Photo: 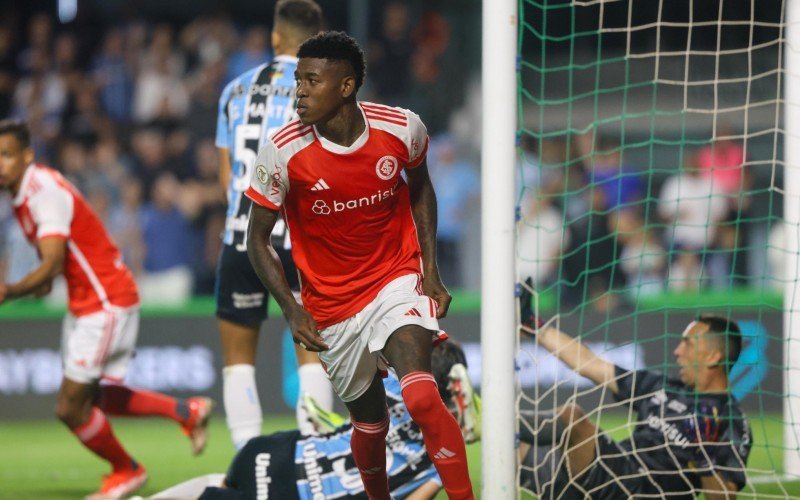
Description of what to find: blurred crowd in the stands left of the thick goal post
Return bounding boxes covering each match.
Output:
[0,2,479,301]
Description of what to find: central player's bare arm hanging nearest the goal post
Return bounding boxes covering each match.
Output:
[406,160,452,318]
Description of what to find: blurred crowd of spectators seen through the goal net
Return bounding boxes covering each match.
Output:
[517,125,782,310]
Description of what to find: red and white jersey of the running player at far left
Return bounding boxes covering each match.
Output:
[14,164,139,316]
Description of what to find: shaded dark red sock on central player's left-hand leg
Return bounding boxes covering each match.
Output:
[350,416,389,500]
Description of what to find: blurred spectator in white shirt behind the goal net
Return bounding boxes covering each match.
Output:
[658,154,727,290]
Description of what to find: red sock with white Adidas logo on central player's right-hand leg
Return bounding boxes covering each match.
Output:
[400,372,474,500]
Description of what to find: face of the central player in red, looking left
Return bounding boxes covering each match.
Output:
[294,57,355,125]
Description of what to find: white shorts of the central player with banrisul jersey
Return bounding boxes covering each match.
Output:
[319,274,447,403]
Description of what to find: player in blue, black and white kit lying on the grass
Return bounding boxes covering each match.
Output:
[145,342,480,500]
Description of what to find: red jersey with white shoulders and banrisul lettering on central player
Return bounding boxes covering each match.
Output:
[246,102,428,329]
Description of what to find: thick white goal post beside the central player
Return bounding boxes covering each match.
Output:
[481,0,517,500]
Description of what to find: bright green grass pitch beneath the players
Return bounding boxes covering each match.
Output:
[0,416,800,500]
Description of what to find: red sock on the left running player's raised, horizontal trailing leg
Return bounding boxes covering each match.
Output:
[99,384,189,423]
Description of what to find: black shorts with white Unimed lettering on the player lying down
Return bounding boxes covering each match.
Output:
[225,431,300,500]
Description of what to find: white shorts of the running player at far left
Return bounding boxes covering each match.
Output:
[61,307,139,384]
